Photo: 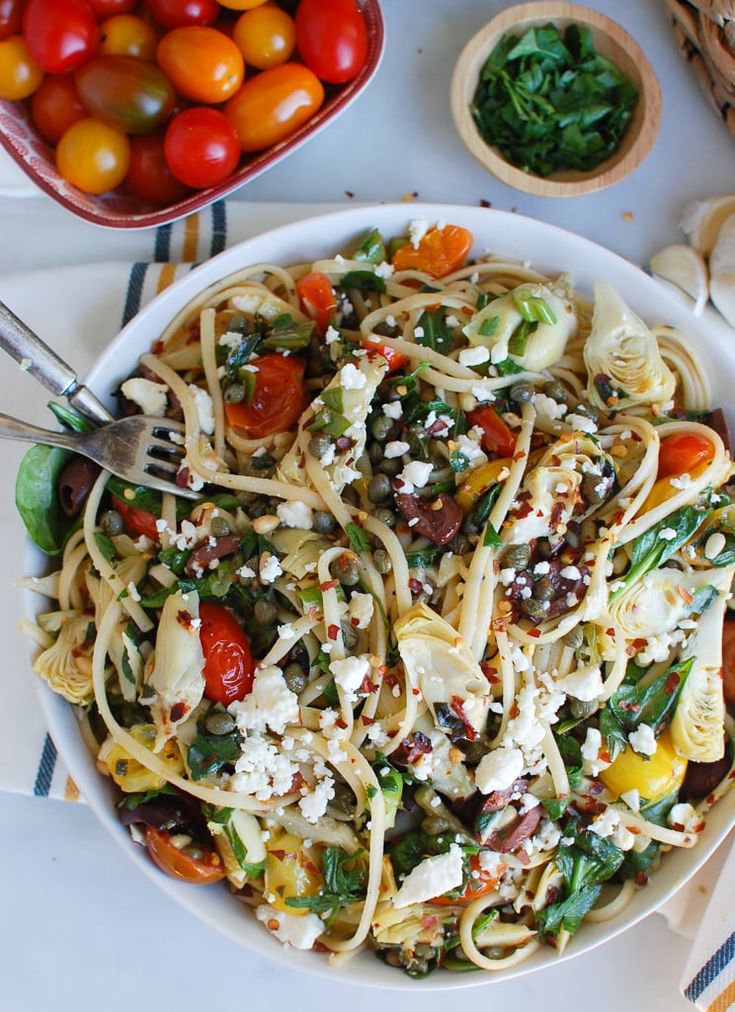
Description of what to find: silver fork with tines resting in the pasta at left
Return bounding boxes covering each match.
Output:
[0,412,199,499]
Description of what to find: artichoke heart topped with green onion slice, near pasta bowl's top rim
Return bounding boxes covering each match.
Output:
[463,284,577,372]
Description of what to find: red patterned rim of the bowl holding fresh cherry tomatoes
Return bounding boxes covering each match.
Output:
[0,0,386,231]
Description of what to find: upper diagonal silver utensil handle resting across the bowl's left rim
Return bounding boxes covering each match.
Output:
[0,302,112,423]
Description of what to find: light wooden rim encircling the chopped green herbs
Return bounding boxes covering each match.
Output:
[451,0,662,197]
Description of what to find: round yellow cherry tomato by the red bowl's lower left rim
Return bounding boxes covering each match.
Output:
[56,118,131,193]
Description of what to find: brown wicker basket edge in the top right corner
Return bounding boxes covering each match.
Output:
[664,0,735,137]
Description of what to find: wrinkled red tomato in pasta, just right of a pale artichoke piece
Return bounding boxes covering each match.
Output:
[199,602,255,706]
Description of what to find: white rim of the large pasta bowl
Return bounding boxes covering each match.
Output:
[23,202,735,993]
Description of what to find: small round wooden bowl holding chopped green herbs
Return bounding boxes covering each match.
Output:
[452,0,661,196]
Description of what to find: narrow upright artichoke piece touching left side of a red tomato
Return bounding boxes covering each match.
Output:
[142,590,205,752]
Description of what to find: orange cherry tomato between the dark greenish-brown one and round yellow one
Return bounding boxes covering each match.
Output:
[156,25,245,103]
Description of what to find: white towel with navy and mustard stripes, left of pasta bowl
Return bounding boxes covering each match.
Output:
[0,198,342,800]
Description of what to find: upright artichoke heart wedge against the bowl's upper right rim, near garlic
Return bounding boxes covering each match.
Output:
[584,282,676,411]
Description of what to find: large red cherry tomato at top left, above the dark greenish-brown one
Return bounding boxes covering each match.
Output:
[23,0,99,74]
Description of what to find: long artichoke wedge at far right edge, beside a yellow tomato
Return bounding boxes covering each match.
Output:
[671,566,735,762]
